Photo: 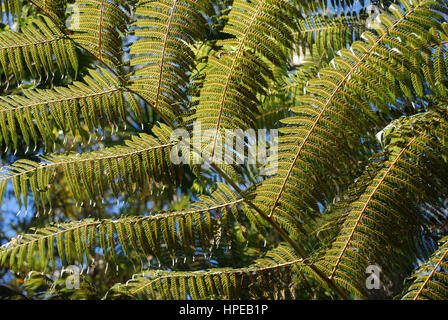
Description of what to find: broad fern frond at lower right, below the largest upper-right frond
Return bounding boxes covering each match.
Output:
[317,113,448,297]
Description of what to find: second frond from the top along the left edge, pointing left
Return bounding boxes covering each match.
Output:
[0,69,141,149]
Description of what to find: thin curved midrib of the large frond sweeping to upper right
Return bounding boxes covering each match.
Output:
[269,6,419,217]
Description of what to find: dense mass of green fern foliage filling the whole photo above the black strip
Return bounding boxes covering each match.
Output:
[0,0,448,299]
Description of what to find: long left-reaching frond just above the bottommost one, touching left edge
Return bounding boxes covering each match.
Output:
[0,185,248,271]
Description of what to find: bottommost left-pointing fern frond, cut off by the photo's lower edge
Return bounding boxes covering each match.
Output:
[106,245,303,300]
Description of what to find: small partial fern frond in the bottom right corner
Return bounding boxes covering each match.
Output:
[402,238,448,300]
